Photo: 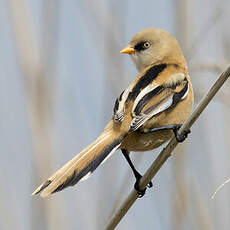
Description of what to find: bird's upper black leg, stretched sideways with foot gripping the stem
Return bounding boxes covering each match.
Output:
[139,124,191,142]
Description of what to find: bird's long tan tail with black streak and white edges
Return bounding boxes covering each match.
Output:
[32,127,124,197]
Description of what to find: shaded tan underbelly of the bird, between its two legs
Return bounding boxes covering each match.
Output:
[120,130,173,151]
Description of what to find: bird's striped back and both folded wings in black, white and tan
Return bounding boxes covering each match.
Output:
[113,64,189,131]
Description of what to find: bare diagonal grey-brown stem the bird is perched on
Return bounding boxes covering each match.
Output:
[106,66,230,230]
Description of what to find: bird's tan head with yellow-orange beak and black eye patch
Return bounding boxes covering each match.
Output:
[120,28,185,71]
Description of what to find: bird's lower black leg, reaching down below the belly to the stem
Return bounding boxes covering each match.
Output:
[121,149,153,198]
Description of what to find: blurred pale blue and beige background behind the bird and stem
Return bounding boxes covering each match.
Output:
[0,0,230,230]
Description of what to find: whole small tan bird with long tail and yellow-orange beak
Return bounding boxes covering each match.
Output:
[32,28,193,197]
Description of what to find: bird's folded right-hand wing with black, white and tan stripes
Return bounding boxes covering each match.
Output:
[130,73,189,131]
